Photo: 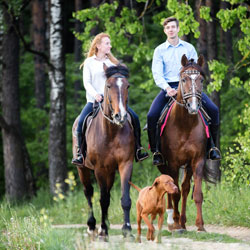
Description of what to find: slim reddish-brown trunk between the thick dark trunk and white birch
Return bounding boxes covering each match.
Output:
[32,0,46,109]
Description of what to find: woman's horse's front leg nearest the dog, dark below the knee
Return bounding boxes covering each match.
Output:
[119,163,133,237]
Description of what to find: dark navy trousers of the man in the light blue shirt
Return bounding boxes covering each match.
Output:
[147,83,219,129]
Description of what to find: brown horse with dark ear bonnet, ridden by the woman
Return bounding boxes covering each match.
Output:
[73,64,135,240]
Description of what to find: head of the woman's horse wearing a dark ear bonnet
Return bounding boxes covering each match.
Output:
[103,64,129,126]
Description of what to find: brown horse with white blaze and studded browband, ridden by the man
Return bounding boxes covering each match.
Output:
[158,55,217,231]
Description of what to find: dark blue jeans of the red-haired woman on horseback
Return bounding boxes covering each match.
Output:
[76,102,140,135]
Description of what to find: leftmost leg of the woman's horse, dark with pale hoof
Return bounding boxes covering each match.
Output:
[77,167,96,237]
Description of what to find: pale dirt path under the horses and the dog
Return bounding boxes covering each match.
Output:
[53,224,250,250]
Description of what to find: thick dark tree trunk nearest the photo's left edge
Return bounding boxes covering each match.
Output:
[0,6,35,200]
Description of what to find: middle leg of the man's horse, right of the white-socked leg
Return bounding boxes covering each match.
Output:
[180,167,193,229]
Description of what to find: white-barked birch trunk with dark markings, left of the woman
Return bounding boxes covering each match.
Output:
[49,0,67,194]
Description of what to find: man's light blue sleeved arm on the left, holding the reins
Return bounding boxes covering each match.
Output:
[152,47,170,90]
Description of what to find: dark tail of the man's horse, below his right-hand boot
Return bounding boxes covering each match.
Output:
[203,159,221,184]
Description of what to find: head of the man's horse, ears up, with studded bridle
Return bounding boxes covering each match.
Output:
[179,54,205,115]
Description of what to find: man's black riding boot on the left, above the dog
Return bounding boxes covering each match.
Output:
[148,129,164,166]
